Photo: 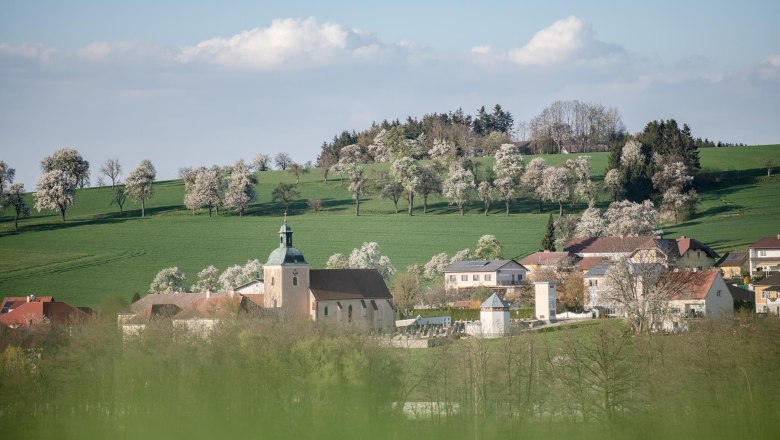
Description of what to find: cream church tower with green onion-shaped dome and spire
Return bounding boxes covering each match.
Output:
[263,220,309,316]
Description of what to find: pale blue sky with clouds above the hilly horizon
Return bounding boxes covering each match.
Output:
[0,0,780,187]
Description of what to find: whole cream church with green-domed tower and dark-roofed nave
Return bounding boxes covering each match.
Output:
[262,220,395,331]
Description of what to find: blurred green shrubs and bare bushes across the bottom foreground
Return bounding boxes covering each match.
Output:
[0,316,780,439]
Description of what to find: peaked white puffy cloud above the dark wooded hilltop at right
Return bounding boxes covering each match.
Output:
[507,15,625,67]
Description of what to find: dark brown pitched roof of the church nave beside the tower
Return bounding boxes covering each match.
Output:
[309,269,393,301]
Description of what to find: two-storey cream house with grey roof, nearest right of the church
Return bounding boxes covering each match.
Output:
[444,260,528,292]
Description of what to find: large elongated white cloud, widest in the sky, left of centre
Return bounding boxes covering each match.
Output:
[177,17,380,70]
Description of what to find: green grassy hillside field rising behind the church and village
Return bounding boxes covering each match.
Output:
[0,145,780,305]
